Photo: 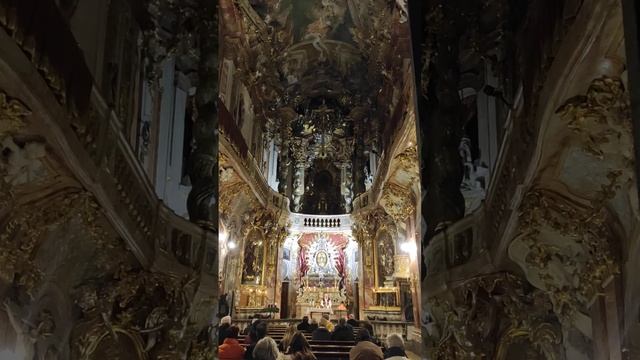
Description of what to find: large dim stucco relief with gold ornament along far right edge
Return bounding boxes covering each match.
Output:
[508,77,637,348]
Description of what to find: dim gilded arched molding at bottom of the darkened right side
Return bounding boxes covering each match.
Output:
[423,273,564,360]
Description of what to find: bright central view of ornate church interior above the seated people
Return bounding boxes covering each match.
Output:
[218,1,421,352]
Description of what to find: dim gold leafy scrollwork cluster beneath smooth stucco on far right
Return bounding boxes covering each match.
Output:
[516,188,619,322]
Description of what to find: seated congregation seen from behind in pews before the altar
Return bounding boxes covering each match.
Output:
[218,315,408,360]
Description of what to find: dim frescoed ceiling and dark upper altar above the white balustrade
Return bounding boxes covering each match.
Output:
[221,0,410,212]
